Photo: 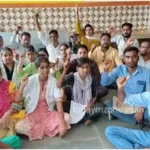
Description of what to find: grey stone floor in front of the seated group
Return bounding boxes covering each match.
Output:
[21,90,143,149]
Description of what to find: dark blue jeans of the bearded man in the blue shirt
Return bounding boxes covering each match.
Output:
[104,100,149,124]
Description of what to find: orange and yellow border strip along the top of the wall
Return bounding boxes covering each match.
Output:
[0,1,150,8]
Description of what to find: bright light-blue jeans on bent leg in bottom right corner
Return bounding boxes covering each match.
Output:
[105,126,150,149]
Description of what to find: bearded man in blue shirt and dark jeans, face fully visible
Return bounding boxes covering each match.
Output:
[101,47,150,124]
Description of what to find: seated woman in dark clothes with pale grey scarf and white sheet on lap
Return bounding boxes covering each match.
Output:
[57,58,103,125]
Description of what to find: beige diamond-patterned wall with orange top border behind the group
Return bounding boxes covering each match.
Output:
[0,2,149,32]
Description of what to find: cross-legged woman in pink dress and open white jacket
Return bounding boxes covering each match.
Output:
[15,56,70,141]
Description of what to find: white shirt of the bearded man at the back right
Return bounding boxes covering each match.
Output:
[111,35,139,58]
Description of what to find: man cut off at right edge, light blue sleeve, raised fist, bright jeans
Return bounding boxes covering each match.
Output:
[105,77,150,149]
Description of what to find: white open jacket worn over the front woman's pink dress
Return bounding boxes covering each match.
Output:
[23,74,62,114]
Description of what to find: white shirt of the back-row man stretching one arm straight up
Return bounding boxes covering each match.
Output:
[38,32,60,63]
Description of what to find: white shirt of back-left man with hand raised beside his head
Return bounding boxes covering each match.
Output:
[10,33,26,54]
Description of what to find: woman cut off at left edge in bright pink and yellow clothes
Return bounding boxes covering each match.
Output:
[0,67,25,139]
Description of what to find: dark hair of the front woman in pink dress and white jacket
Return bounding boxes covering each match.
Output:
[35,54,49,68]
